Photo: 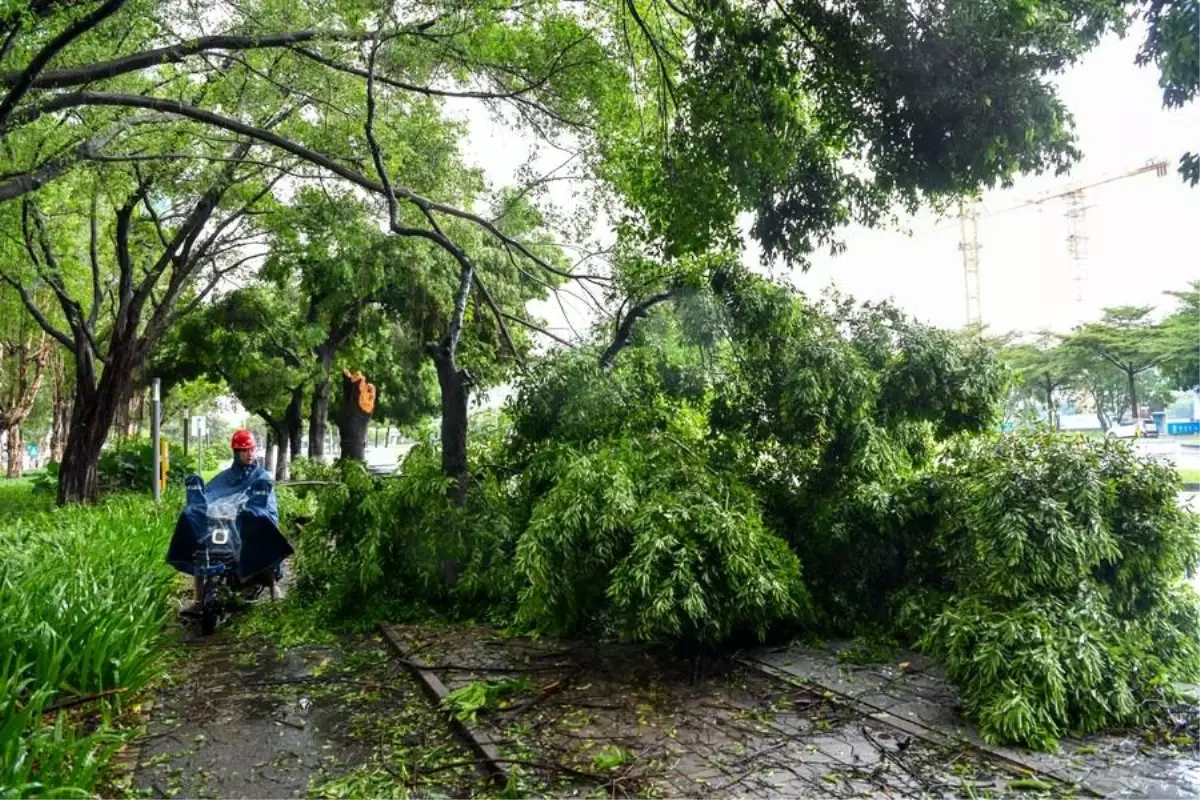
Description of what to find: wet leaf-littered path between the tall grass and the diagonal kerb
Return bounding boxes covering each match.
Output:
[133,632,482,800]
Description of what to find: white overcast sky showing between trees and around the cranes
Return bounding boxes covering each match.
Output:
[453,29,1200,335]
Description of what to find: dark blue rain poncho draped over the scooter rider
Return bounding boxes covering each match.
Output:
[167,462,292,578]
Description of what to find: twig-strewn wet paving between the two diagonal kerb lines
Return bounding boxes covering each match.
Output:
[381,626,1070,799]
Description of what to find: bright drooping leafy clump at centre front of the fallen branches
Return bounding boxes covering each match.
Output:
[517,439,809,644]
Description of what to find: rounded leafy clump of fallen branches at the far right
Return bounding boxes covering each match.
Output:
[920,434,1200,750]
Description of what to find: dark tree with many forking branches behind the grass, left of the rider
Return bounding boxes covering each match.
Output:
[0,154,278,503]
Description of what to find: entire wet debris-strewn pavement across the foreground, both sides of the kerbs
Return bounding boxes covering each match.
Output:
[133,626,1200,800]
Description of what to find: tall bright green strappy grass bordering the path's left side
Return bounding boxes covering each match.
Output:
[0,482,176,800]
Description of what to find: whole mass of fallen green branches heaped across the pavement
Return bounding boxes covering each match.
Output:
[288,269,1200,747]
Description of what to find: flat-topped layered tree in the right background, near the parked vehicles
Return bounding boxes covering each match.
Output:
[1066,306,1165,419]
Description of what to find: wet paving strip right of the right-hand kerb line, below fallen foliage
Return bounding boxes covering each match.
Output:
[743,644,1200,800]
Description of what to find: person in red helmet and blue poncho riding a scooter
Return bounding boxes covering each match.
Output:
[168,429,292,614]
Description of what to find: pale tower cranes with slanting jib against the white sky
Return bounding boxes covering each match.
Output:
[959,160,1170,327]
